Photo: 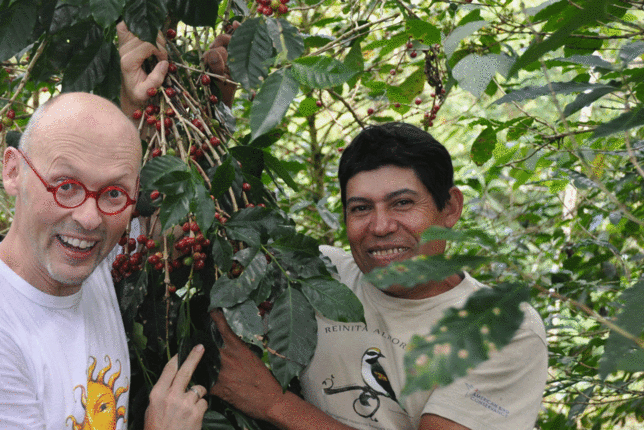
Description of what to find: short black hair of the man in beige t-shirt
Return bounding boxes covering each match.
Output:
[338,122,454,210]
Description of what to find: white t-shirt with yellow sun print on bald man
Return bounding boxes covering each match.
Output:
[0,260,130,430]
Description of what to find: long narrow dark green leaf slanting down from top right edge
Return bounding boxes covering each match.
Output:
[508,0,607,77]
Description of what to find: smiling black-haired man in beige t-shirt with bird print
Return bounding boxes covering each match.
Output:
[212,123,548,430]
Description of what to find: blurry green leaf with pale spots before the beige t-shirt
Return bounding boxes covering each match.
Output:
[403,284,530,395]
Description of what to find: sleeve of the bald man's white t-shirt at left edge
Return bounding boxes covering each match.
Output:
[0,331,45,430]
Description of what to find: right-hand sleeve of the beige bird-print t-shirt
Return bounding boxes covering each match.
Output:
[423,310,548,430]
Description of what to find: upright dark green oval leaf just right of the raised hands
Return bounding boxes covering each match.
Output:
[228,18,273,89]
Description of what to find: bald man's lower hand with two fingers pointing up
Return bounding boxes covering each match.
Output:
[145,345,208,430]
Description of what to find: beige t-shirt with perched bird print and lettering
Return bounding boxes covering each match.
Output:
[300,246,548,430]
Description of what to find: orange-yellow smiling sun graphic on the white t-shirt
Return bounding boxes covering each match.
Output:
[67,356,129,430]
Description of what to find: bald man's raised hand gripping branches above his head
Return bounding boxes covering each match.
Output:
[116,21,168,117]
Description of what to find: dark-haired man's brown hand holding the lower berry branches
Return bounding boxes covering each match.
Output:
[210,310,284,420]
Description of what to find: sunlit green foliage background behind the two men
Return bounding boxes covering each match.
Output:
[0,0,644,429]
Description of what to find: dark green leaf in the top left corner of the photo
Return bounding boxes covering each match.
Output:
[0,1,38,62]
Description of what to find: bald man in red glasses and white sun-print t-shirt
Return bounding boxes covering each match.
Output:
[0,93,207,430]
